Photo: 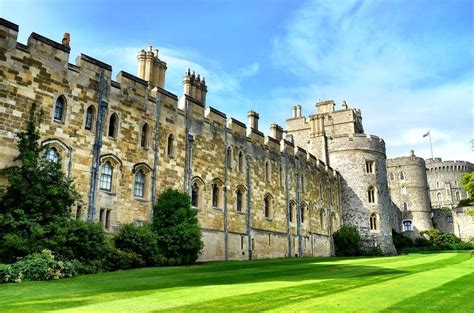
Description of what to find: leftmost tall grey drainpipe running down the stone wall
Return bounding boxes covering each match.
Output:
[87,71,108,222]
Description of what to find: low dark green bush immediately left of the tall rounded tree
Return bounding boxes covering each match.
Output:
[114,224,161,266]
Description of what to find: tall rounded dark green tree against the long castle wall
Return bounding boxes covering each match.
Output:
[153,189,203,264]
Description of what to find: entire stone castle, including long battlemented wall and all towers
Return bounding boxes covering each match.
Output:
[0,19,473,261]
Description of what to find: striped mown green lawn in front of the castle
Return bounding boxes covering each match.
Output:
[0,252,474,312]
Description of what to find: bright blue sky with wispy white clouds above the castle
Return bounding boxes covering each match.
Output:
[0,0,474,161]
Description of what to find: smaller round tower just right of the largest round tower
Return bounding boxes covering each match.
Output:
[387,150,433,238]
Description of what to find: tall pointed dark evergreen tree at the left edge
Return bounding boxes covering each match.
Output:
[0,104,79,262]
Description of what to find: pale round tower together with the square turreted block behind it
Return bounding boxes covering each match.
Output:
[286,100,396,254]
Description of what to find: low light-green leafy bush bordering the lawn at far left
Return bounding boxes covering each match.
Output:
[0,250,77,283]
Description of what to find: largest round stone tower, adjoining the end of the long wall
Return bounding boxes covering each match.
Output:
[328,134,396,254]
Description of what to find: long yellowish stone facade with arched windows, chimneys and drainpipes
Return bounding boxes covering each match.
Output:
[0,19,342,261]
